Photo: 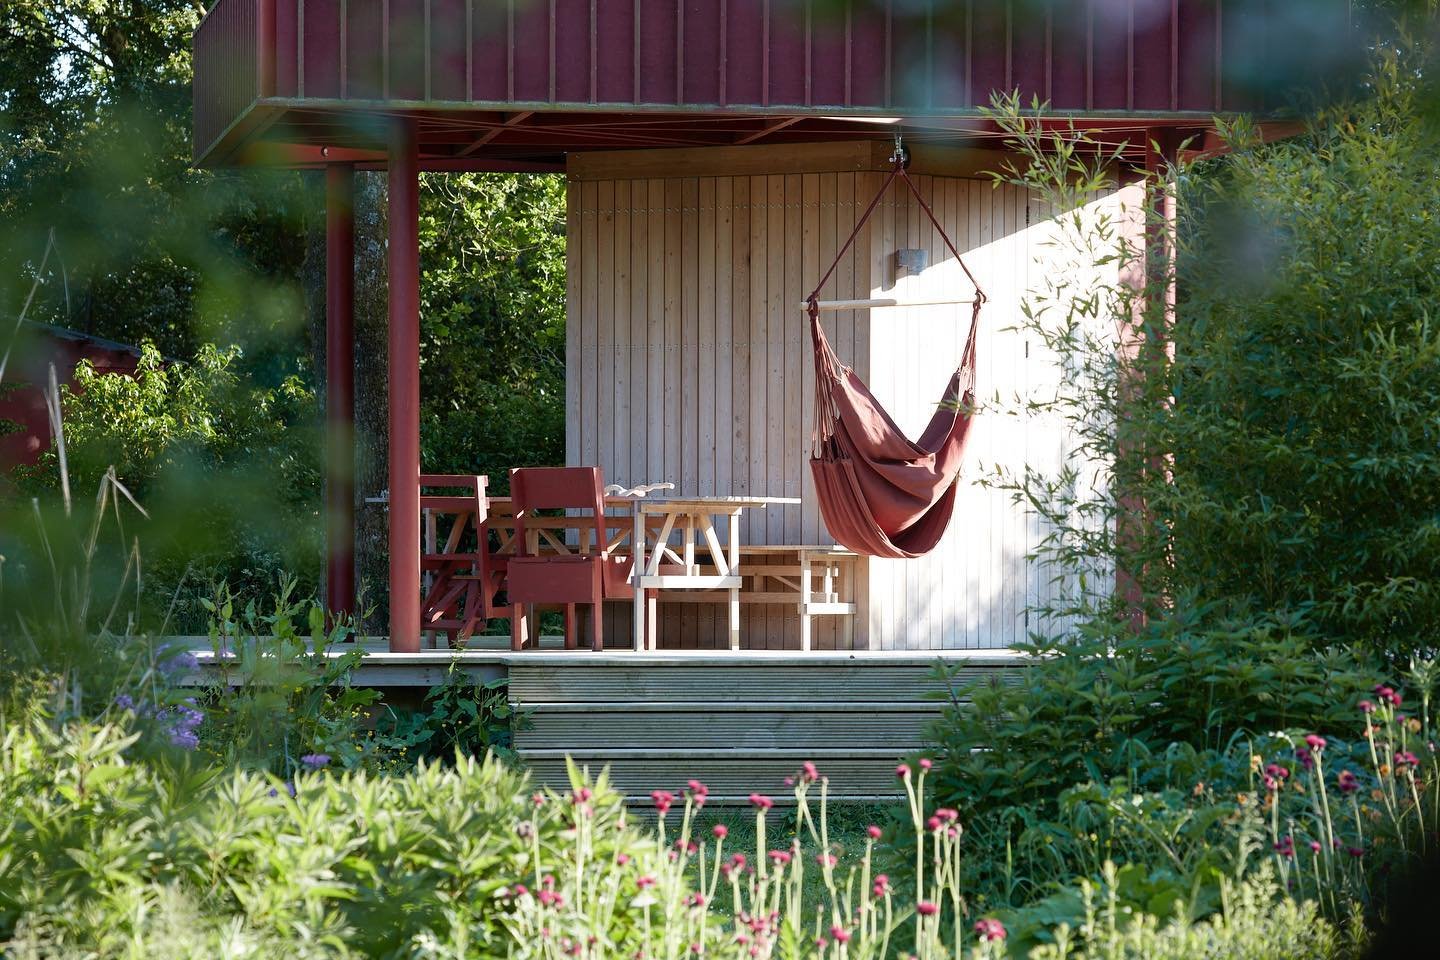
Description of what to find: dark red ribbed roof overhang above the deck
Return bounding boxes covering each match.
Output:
[194,0,1348,170]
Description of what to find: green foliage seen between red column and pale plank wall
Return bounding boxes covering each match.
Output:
[420,174,564,483]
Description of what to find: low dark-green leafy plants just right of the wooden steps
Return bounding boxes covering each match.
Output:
[932,604,1374,816]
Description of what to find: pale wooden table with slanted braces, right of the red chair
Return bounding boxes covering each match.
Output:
[631,497,801,651]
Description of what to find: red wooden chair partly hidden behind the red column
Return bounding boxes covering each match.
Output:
[420,474,510,646]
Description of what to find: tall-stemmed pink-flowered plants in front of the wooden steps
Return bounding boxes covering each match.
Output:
[503,760,1005,960]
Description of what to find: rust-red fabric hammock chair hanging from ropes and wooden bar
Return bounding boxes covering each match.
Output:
[805,147,985,560]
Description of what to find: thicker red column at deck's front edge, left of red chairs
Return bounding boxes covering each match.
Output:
[387,119,420,653]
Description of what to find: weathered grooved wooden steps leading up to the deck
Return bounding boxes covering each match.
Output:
[507,651,1021,803]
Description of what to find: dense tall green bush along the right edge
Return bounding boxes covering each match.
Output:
[1163,52,1440,653]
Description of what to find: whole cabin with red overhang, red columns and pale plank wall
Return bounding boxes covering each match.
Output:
[194,0,1348,651]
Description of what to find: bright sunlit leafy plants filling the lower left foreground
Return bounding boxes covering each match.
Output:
[0,721,647,957]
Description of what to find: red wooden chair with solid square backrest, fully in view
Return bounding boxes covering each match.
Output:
[505,466,635,651]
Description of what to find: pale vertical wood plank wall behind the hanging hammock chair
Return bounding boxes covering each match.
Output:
[566,150,1117,651]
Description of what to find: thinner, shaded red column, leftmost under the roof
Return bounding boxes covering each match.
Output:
[325,164,356,615]
